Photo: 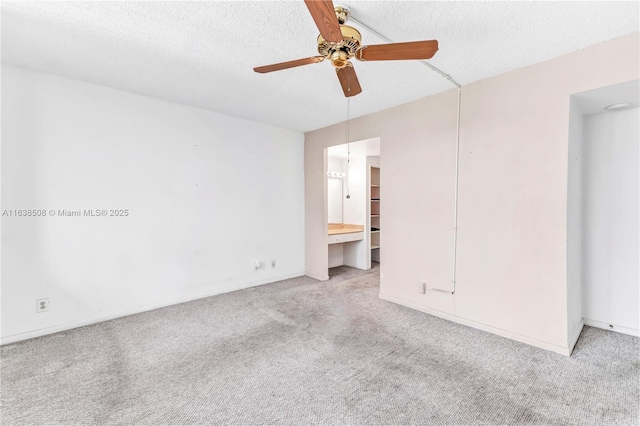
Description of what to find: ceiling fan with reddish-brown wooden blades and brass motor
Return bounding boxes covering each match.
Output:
[253,0,438,97]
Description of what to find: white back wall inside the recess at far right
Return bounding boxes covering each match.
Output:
[582,108,640,335]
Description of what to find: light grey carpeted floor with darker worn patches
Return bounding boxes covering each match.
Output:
[0,267,640,425]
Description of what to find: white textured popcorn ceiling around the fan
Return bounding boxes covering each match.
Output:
[2,0,639,131]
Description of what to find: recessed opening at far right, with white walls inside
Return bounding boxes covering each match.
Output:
[567,80,640,340]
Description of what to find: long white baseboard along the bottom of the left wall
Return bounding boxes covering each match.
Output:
[0,272,304,345]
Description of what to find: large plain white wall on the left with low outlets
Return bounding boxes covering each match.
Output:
[1,65,304,343]
